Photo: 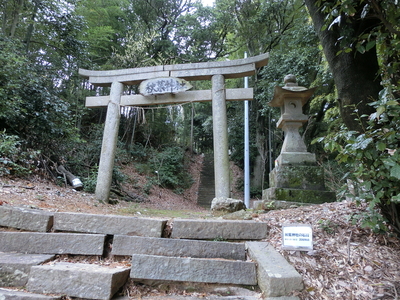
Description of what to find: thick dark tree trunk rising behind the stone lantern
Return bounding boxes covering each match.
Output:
[305,0,382,132]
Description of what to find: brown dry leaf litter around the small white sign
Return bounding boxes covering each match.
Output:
[259,201,400,300]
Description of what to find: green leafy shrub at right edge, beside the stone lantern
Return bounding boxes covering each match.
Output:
[318,88,400,230]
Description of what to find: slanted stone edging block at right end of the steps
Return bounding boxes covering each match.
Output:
[246,242,304,299]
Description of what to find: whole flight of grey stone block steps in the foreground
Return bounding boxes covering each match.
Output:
[0,206,303,300]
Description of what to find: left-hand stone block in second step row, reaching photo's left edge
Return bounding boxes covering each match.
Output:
[0,232,106,255]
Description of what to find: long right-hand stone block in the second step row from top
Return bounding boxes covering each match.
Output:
[112,235,246,260]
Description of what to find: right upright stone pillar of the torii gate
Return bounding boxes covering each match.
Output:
[211,75,230,198]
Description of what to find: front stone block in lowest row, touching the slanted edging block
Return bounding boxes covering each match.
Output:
[130,254,257,285]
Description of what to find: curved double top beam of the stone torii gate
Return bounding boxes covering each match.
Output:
[79,53,269,86]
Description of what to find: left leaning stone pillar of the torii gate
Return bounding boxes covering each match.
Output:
[95,81,124,202]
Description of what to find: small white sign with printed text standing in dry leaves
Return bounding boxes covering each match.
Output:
[282,224,313,251]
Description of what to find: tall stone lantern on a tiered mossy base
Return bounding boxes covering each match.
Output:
[262,75,336,204]
